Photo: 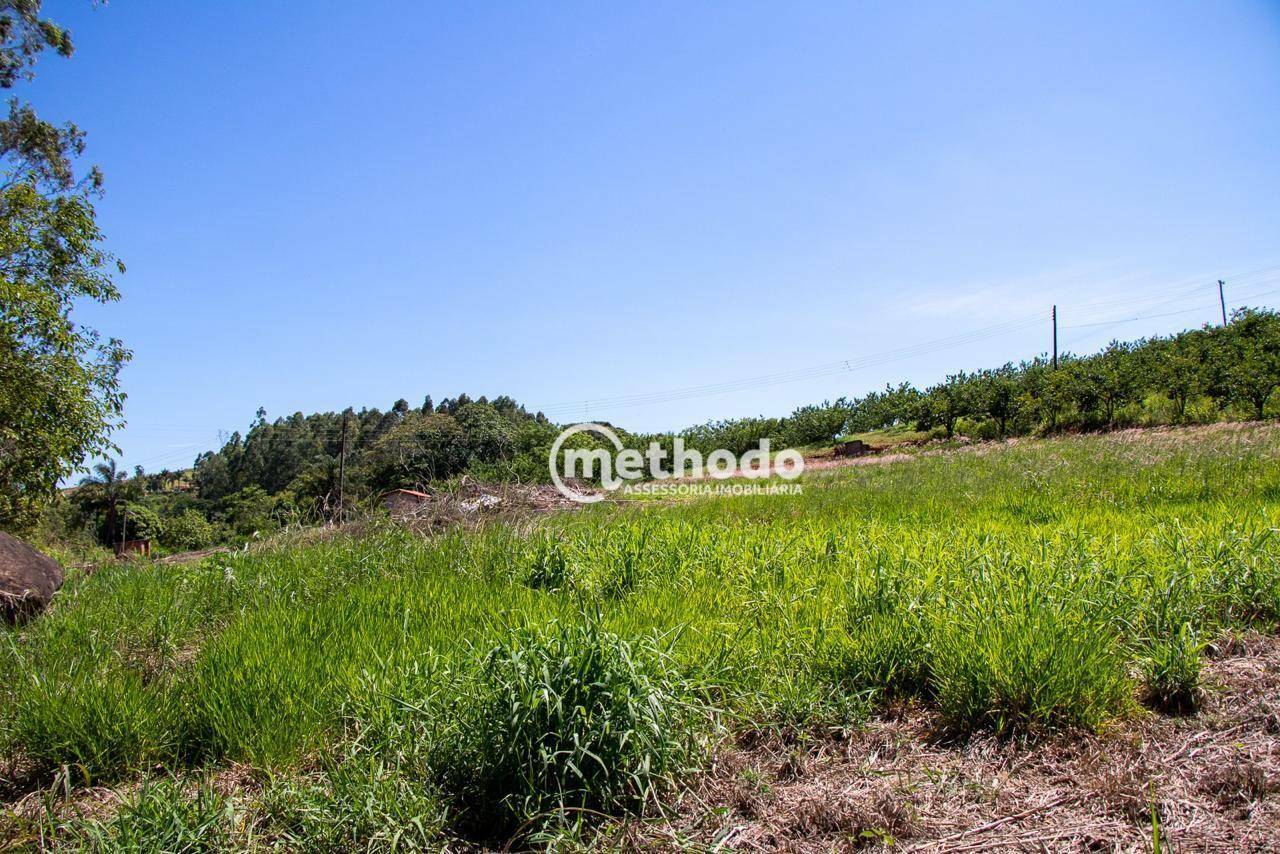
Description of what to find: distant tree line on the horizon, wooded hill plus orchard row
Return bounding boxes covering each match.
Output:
[42,309,1280,549]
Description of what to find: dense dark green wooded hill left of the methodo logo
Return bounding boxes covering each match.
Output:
[45,394,558,551]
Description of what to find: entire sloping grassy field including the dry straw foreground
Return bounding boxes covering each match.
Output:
[0,425,1280,850]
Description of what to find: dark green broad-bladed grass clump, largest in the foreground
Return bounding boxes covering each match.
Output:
[445,620,707,832]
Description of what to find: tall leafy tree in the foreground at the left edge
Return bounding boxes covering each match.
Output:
[0,0,129,530]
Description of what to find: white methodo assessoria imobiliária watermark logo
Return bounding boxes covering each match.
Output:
[548,424,804,504]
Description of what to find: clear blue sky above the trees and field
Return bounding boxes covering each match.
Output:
[27,0,1280,470]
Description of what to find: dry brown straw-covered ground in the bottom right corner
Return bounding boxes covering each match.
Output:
[608,635,1280,851]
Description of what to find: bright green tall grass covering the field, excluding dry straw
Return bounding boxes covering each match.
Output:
[0,425,1280,839]
